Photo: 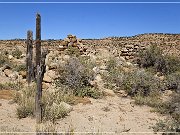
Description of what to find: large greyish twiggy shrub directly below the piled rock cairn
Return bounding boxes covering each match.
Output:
[55,57,98,97]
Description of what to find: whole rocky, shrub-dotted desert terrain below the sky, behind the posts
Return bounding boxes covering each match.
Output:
[0,34,180,134]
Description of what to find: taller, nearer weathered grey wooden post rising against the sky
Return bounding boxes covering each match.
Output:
[35,14,43,123]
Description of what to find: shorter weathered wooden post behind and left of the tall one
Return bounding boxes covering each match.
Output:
[26,30,33,84]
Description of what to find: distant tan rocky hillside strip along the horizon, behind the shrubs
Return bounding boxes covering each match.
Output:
[0,33,180,60]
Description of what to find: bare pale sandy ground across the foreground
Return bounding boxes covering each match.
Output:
[0,93,164,135]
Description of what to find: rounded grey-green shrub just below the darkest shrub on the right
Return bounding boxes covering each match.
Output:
[122,70,164,97]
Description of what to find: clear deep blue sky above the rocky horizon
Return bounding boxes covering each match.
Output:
[0,0,180,39]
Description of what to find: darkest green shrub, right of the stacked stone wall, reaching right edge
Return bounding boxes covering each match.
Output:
[138,45,180,74]
